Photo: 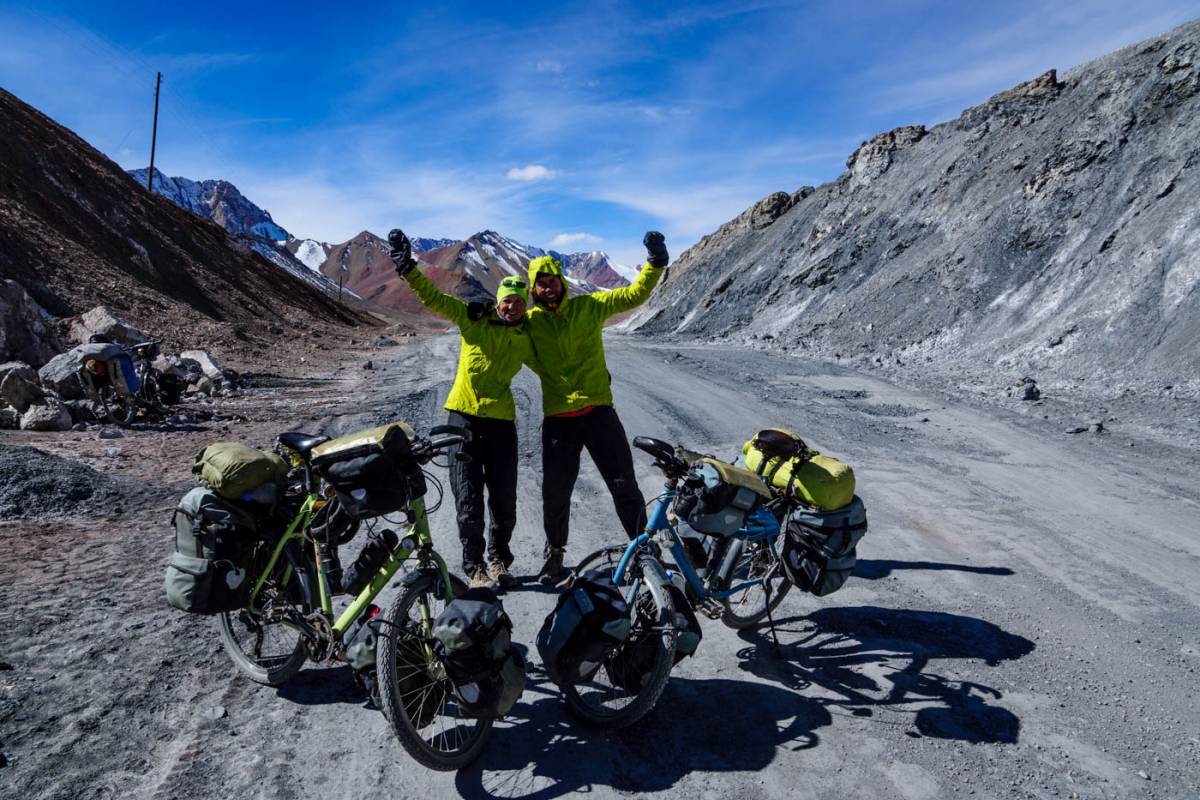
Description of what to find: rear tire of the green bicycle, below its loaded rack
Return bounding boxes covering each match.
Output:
[217,551,308,686]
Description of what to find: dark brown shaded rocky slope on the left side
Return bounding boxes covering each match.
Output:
[0,90,365,369]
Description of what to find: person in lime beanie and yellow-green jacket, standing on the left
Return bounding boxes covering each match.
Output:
[388,230,533,588]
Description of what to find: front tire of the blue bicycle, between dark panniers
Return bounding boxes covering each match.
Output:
[562,556,677,730]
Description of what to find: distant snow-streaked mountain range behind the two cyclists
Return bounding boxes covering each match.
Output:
[130,168,630,318]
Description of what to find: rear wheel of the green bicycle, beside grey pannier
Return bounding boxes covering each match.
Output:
[217,547,308,686]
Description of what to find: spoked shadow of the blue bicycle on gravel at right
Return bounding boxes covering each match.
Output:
[737,606,1036,744]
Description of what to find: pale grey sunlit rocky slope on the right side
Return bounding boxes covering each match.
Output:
[629,22,1200,391]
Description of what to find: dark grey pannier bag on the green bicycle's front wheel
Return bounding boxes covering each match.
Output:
[433,588,526,720]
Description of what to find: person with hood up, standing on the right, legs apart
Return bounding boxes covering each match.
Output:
[528,230,670,584]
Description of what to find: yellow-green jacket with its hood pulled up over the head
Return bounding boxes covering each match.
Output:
[527,255,662,416]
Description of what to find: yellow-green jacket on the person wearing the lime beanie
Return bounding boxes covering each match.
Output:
[404,267,533,420]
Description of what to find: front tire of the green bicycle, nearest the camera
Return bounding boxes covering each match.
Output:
[376,575,492,771]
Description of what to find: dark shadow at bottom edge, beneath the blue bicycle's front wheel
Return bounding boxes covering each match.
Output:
[455,675,833,800]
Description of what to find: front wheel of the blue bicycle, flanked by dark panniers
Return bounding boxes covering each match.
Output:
[562,548,676,729]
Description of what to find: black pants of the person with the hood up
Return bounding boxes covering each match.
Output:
[541,405,646,547]
